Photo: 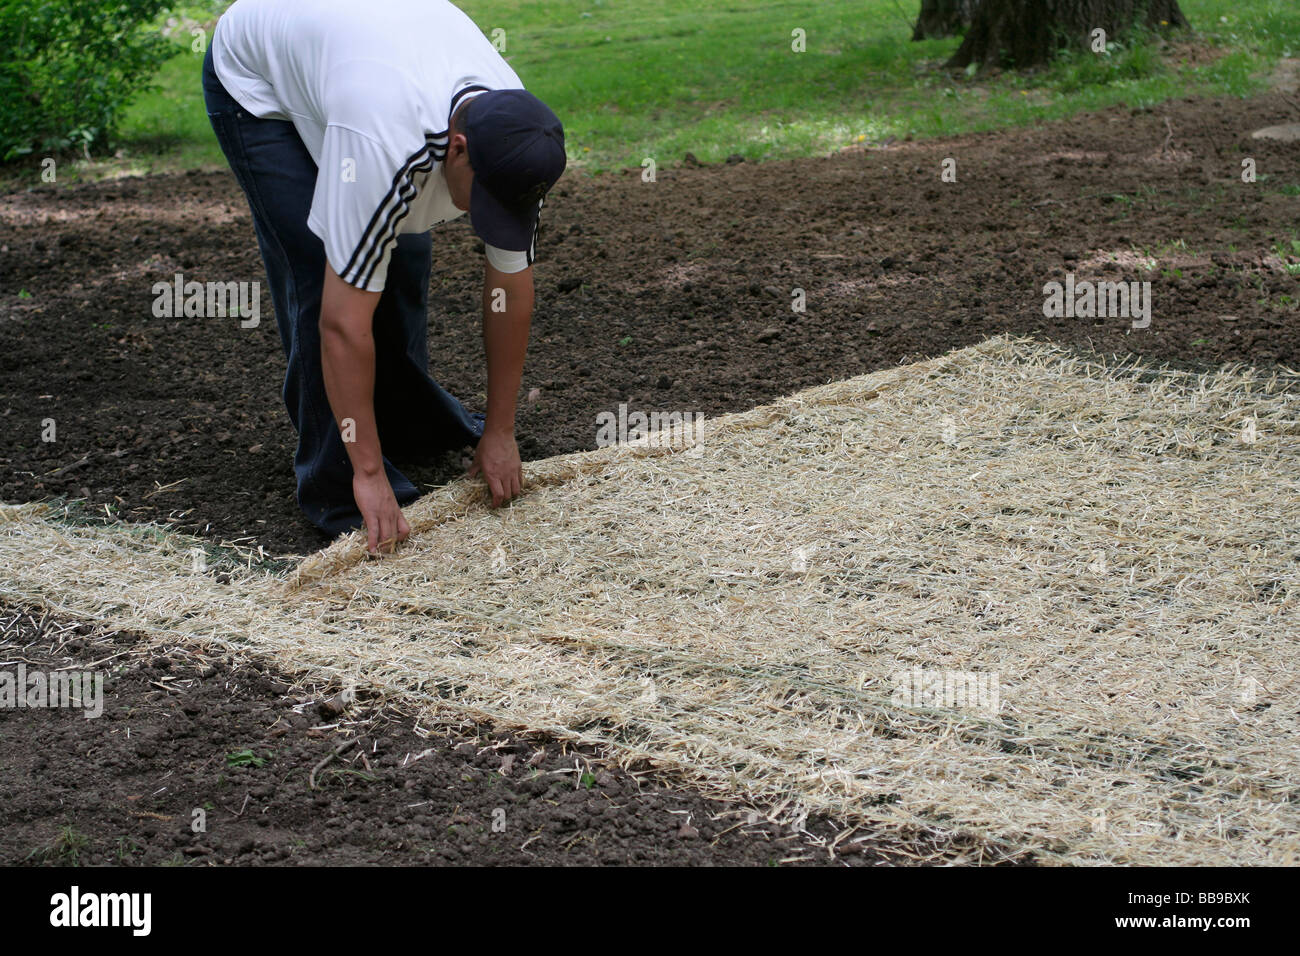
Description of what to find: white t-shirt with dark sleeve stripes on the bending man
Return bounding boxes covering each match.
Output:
[212,0,530,291]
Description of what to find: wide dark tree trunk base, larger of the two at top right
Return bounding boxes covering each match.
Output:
[948,0,1190,69]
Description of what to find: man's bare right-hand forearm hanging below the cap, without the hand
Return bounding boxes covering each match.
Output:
[482,264,533,434]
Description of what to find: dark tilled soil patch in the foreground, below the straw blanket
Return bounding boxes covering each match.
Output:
[0,609,961,865]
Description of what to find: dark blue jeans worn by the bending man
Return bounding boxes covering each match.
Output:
[203,47,484,535]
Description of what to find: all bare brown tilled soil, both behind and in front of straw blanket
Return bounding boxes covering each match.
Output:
[0,94,1300,864]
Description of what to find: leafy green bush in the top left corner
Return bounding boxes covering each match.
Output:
[0,0,176,161]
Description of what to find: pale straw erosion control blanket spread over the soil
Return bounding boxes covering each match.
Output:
[0,338,1300,864]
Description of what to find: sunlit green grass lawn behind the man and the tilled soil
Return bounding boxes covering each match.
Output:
[20,0,1300,181]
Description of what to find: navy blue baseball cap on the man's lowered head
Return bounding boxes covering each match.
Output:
[464,90,567,252]
